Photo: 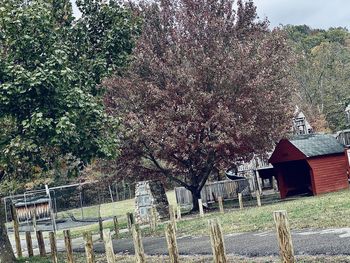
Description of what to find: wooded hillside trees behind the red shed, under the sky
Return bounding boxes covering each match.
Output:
[285,25,350,131]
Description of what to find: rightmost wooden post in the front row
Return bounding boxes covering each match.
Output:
[273,210,295,263]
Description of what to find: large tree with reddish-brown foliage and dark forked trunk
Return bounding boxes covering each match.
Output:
[104,0,294,210]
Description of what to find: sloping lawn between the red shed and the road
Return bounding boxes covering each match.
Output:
[174,190,350,235]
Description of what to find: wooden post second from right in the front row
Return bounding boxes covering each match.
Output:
[208,219,227,263]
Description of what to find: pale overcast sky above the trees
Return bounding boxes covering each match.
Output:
[71,0,350,29]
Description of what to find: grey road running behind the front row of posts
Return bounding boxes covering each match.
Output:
[69,228,350,257]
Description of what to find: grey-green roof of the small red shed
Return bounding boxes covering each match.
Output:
[289,134,344,157]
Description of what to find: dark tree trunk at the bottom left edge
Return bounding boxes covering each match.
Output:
[0,196,16,263]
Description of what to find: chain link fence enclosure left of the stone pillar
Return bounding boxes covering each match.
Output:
[4,181,135,231]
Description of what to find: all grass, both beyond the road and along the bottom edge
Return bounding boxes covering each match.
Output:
[12,190,350,263]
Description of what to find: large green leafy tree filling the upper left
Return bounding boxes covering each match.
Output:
[0,0,138,262]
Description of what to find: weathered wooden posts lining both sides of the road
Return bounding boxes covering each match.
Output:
[8,194,295,263]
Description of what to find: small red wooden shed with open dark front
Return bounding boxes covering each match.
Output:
[269,134,348,198]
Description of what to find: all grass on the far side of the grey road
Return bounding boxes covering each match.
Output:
[54,190,350,240]
